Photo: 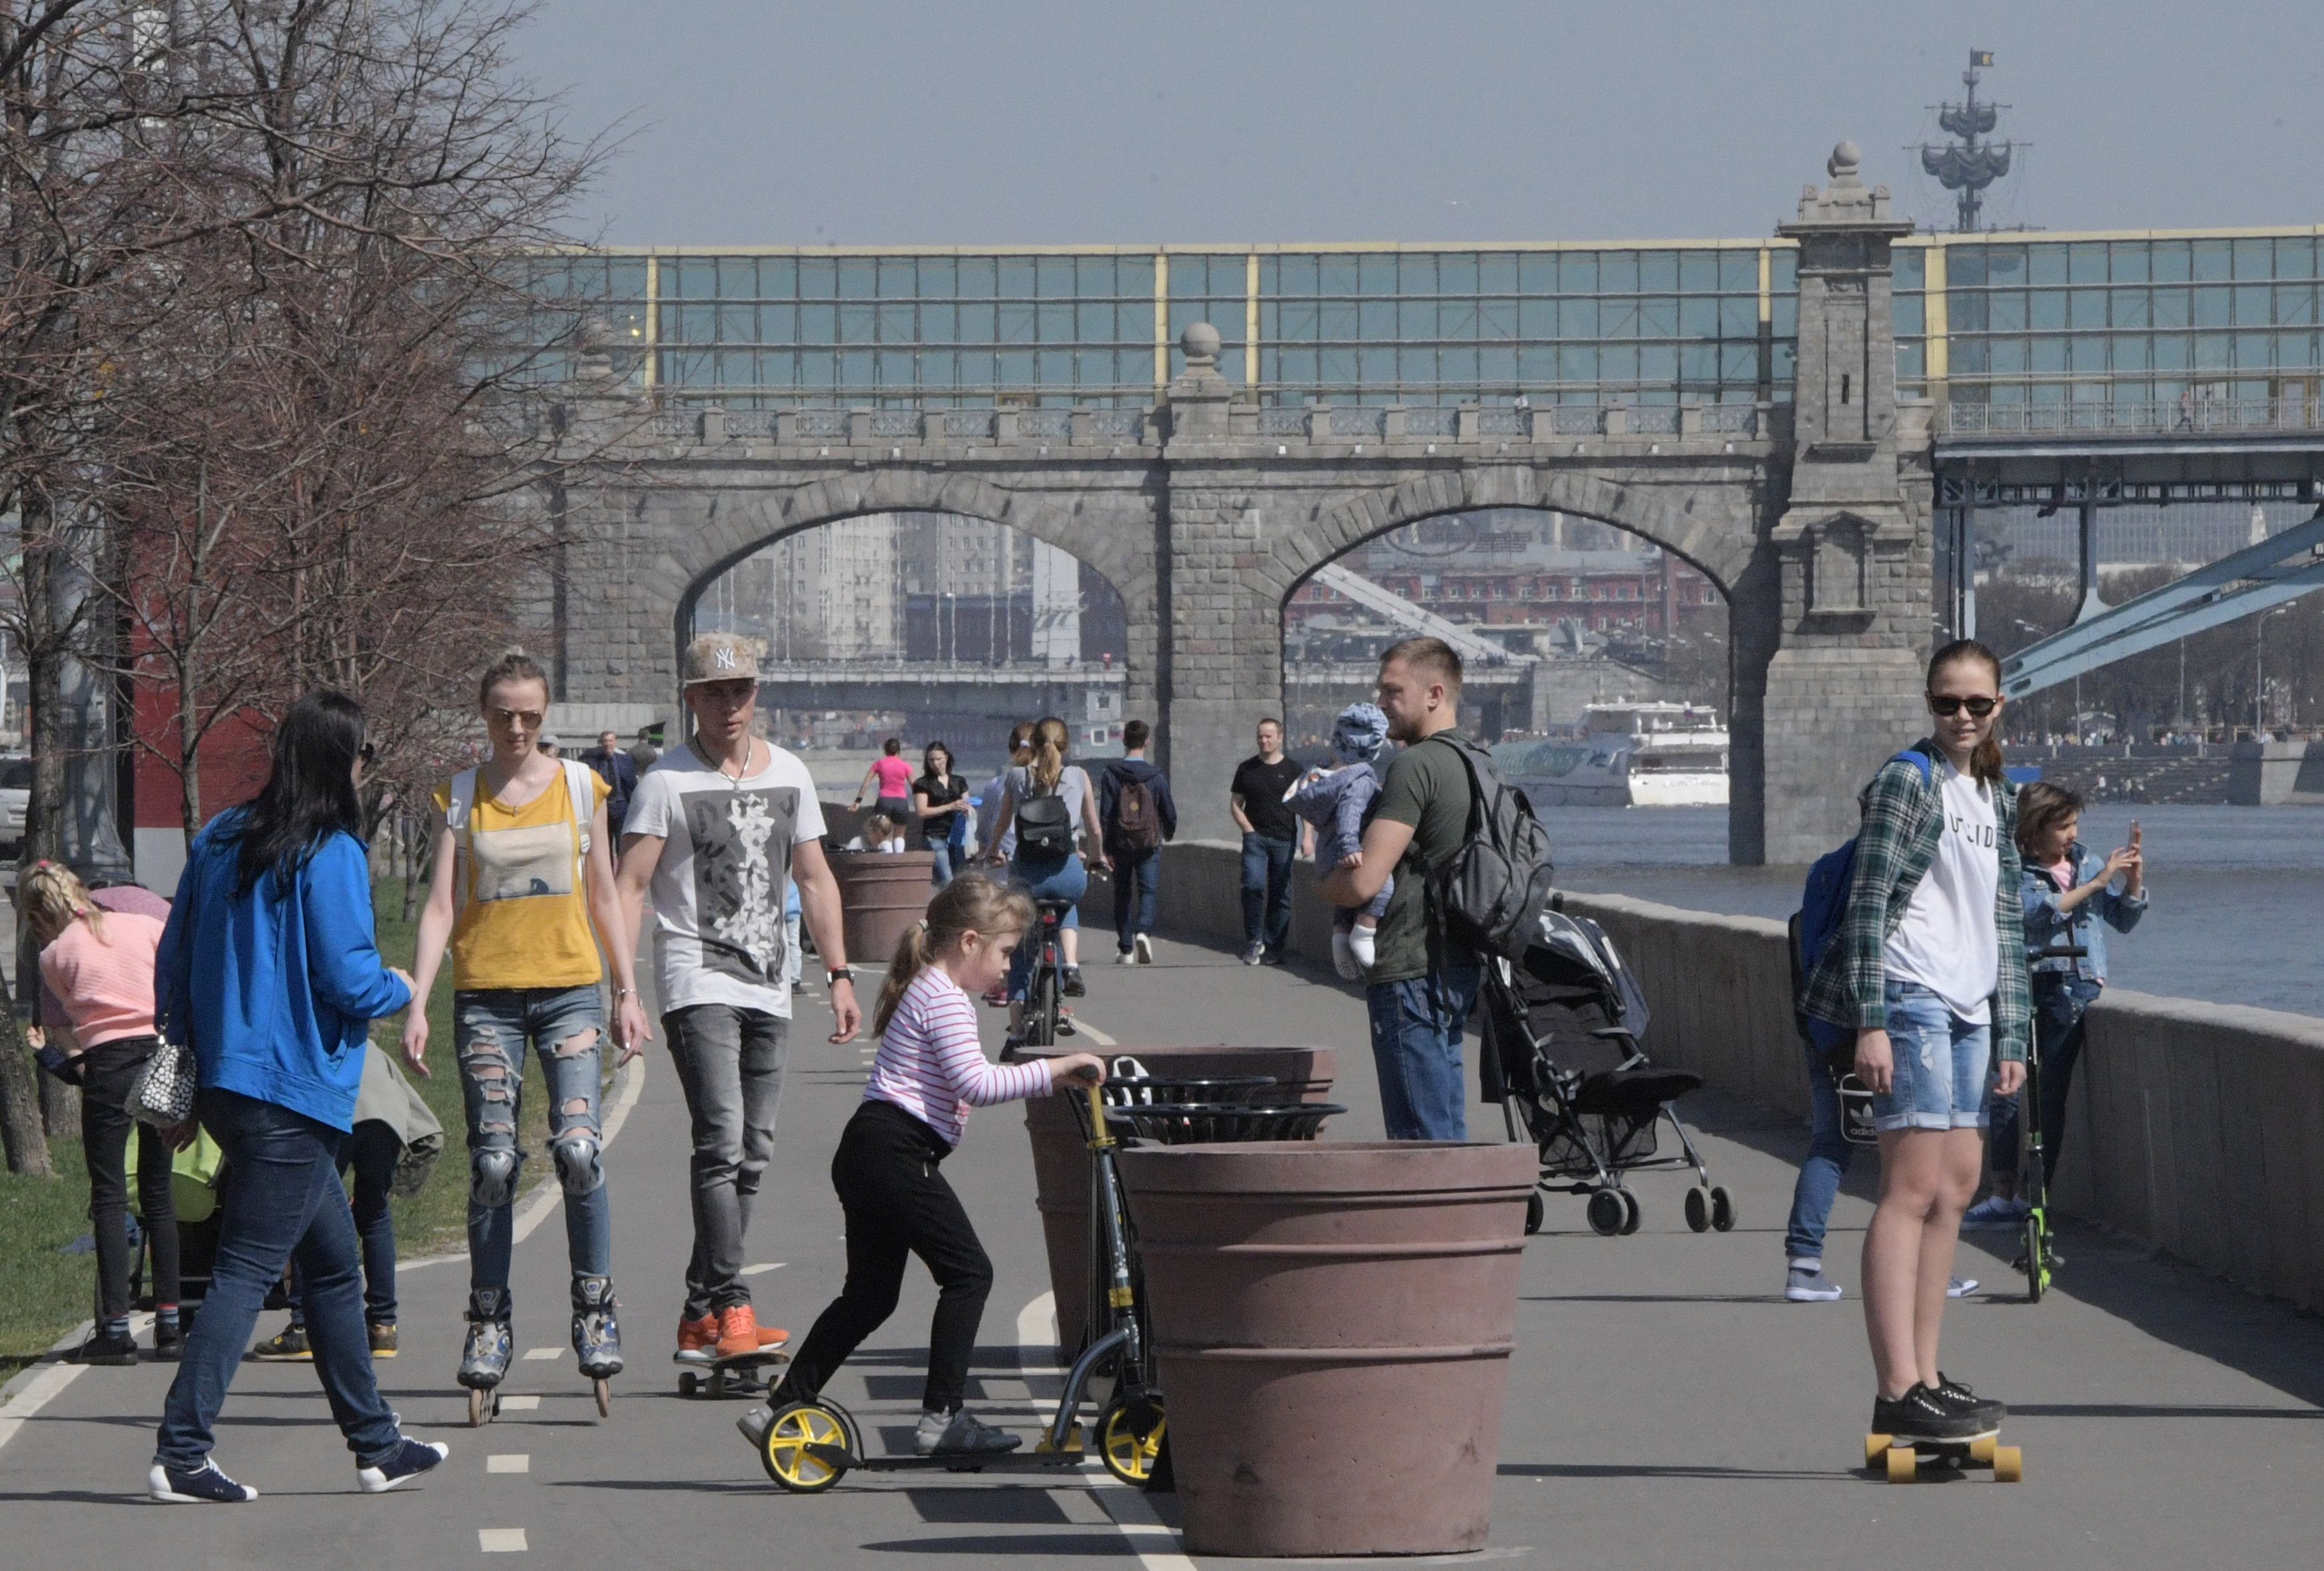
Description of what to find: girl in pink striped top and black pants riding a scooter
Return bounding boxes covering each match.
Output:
[739,879,1106,1457]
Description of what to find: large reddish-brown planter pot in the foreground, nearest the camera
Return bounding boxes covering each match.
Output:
[1120,1141,1536,1555]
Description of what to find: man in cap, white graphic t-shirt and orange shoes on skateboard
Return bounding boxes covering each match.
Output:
[618,632,862,1364]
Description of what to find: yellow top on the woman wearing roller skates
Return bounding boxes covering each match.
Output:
[434,767,611,987]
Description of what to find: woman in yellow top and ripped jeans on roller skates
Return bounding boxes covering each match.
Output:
[404,651,648,1420]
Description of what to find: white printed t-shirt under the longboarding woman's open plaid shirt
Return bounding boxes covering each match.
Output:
[1882,758,2001,1025]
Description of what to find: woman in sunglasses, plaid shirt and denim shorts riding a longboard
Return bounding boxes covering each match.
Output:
[1801,639,2029,1443]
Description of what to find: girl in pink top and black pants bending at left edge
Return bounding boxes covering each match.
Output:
[16,862,181,1364]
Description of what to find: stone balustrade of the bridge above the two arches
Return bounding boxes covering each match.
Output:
[648,404,1766,448]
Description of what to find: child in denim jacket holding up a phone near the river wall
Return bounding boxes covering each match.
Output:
[1962,781,2147,1227]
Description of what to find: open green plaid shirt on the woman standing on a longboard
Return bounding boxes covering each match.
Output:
[1801,739,2034,1062]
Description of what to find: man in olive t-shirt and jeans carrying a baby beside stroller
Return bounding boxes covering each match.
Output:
[1318,637,1489,1141]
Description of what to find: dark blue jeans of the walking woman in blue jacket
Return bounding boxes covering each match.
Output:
[153,1085,402,1471]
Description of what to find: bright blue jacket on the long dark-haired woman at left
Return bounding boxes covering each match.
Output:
[153,809,412,1129]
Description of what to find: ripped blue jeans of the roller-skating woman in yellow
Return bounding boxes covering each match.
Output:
[451,983,613,1292]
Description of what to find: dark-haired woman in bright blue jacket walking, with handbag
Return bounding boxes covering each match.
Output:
[147,690,451,1501]
